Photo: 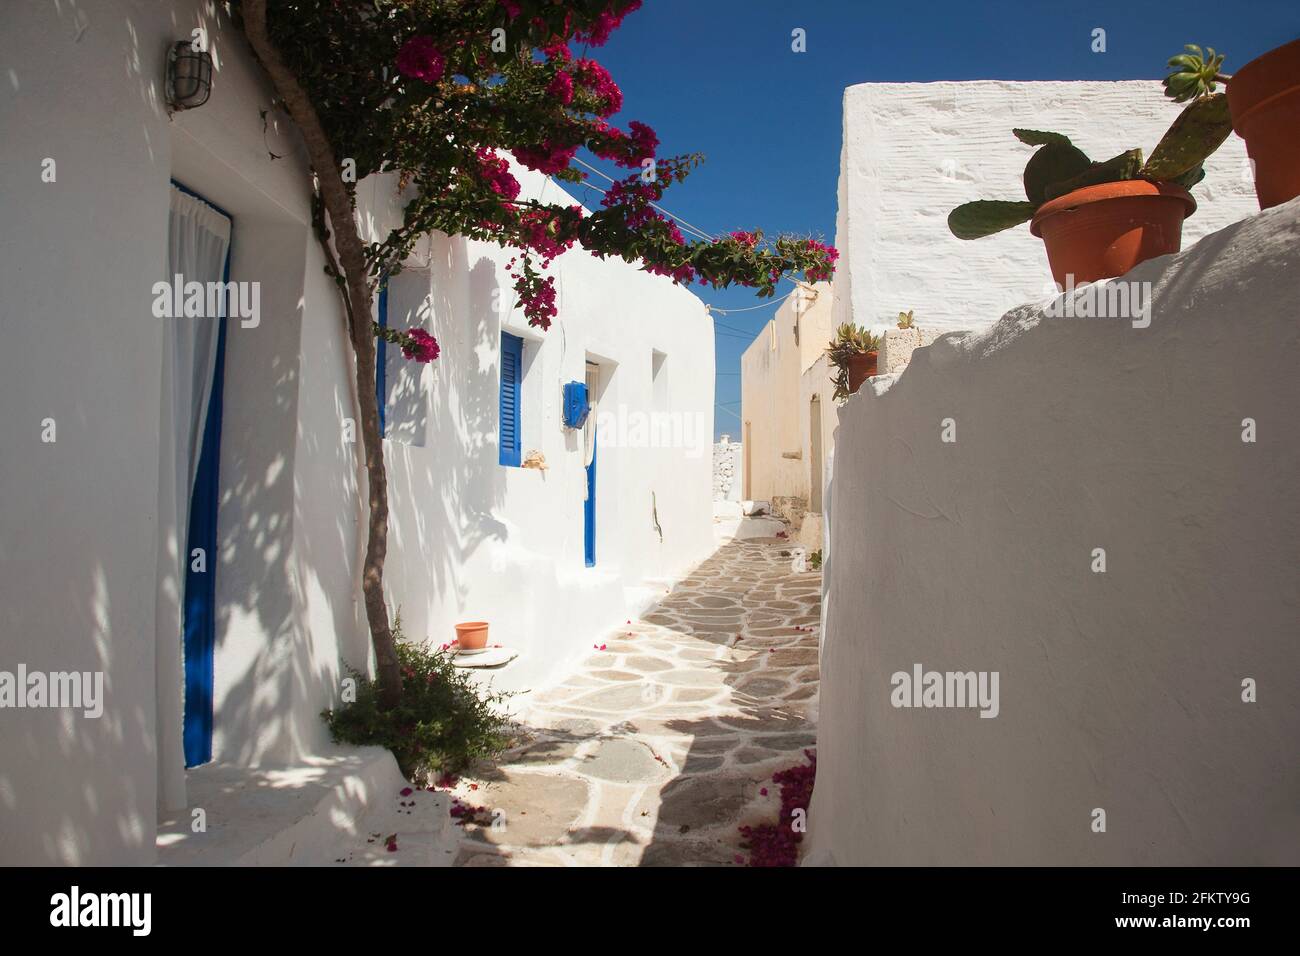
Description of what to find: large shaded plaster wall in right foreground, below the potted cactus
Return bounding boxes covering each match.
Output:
[805,200,1300,865]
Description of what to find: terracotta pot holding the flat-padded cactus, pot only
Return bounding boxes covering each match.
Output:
[1030,179,1196,286]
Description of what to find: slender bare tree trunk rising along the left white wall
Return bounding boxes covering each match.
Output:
[241,0,402,709]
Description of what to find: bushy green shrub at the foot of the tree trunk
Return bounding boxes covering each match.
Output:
[321,615,510,786]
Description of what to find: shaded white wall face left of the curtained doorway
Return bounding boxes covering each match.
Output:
[0,3,200,865]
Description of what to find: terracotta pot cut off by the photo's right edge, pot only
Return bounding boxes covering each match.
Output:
[1227,40,1300,209]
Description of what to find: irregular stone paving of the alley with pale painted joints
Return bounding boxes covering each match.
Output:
[455,522,822,866]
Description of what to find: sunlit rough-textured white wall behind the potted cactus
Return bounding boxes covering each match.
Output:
[835,79,1258,330]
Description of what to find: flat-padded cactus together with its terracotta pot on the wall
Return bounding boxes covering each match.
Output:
[948,85,1230,286]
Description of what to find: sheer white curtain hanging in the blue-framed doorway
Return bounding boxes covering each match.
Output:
[155,186,230,810]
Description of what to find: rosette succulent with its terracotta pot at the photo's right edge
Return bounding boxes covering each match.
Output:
[1165,39,1300,209]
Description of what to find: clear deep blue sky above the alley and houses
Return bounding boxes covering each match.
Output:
[584,0,1300,436]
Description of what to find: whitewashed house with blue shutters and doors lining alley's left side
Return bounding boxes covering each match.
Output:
[0,0,714,864]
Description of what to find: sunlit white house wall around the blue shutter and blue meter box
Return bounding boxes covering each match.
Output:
[376,168,714,689]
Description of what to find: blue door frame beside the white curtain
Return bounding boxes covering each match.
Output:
[172,179,234,767]
